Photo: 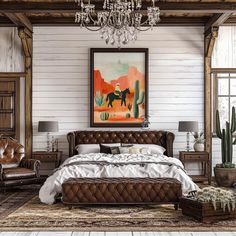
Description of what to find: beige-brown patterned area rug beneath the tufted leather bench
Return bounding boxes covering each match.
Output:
[0,196,236,232]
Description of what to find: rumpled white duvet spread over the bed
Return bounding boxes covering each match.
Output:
[39,153,199,204]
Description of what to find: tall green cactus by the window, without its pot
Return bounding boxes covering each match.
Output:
[216,107,236,168]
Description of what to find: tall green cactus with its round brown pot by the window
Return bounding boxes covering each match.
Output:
[214,107,236,187]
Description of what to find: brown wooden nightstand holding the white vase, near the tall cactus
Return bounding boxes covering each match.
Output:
[179,151,211,184]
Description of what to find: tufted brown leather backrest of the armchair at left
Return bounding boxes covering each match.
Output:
[0,138,25,168]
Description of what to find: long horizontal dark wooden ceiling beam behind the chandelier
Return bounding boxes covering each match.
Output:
[0,1,236,13]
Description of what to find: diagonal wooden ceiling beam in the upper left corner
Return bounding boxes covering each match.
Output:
[4,13,33,32]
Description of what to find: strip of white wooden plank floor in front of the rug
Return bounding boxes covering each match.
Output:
[0,232,236,236]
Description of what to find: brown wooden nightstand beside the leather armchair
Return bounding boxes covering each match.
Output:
[32,151,62,175]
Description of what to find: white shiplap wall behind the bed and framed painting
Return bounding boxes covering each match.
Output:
[33,27,204,172]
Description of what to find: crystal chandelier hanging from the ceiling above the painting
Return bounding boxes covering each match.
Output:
[75,0,160,47]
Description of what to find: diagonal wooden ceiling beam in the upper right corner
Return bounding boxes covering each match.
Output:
[205,12,233,37]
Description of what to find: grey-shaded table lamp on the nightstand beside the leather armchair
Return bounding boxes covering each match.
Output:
[38,121,59,152]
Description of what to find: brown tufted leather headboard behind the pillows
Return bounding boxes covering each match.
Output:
[67,131,175,157]
